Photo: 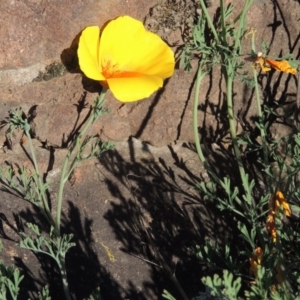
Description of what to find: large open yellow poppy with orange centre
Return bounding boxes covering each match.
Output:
[77,16,175,102]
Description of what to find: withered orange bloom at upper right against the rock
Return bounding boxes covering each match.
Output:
[255,52,297,75]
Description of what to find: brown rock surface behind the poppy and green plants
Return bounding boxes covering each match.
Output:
[0,0,300,300]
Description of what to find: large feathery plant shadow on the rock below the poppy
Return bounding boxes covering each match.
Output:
[100,139,230,299]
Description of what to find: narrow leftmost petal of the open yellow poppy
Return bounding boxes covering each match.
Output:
[77,26,104,80]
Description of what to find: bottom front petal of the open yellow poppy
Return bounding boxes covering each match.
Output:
[107,75,163,102]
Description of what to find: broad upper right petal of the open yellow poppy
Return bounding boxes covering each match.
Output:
[100,16,175,79]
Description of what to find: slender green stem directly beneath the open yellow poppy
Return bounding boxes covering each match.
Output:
[56,89,107,236]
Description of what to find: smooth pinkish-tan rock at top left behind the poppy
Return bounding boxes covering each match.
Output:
[0,0,154,69]
